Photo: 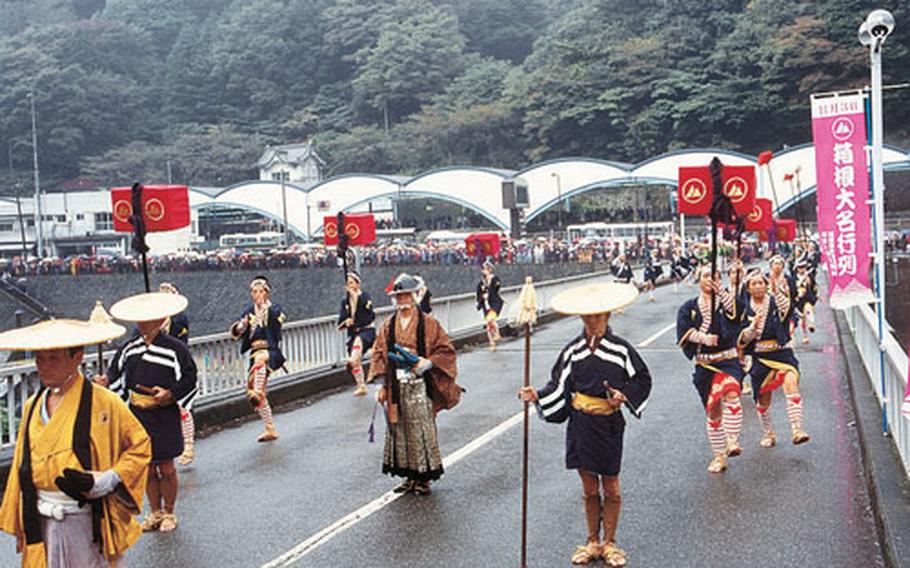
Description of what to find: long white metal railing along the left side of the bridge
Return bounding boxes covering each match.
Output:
[0,271,609,448]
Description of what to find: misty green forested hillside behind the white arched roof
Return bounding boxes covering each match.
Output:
[0,0,910,191]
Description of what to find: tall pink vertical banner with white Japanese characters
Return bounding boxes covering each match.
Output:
[812,93,875,310]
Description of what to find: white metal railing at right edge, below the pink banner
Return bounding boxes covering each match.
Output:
[846,305,910,475]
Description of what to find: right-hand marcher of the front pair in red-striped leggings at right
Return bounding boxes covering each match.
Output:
[737,270,809,448]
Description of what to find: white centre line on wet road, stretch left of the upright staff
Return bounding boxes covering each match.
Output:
[262,412,524,568]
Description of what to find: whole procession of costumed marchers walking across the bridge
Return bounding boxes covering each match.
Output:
[0,235,817,566]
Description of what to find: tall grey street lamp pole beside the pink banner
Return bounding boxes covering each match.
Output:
[857,10,894,433]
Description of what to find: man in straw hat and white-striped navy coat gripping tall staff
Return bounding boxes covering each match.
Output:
[519,283,651,566]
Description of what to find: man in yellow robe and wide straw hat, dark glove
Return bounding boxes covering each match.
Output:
[0,319,152,568]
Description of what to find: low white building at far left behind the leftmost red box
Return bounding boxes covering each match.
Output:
[0,189,196,257]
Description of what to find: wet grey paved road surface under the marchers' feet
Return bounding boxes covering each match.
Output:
[0,278,882,568]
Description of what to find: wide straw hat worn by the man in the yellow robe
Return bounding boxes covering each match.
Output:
[0,319,126,351]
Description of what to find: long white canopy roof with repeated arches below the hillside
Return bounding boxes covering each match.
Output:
[190,144,910,237]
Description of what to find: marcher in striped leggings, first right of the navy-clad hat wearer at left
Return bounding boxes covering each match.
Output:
[231,276,287,442]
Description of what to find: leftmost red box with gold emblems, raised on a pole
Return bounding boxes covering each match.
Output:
[111,185,190,233]
